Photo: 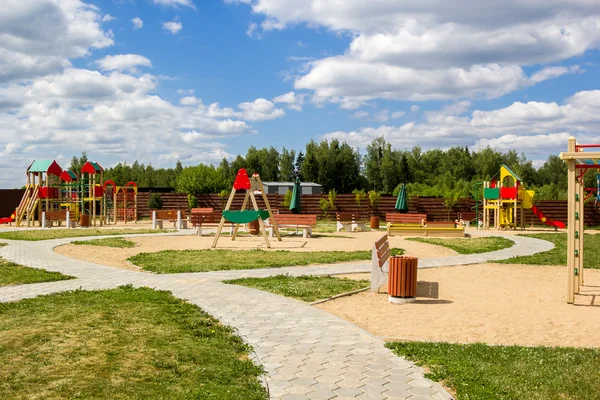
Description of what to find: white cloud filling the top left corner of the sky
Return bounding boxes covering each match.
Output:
[0,0,113,84]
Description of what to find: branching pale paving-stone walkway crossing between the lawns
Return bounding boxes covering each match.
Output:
[0,234,553,400]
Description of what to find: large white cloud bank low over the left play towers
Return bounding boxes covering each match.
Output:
[0,68,284,187]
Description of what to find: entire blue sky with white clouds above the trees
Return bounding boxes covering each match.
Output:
[0,0,600,188]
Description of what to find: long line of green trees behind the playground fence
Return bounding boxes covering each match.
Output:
[71,137,597,200]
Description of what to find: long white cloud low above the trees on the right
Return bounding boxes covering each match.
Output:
[323,90,600,158]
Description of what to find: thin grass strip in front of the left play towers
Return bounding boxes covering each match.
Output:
[0,228,168,241]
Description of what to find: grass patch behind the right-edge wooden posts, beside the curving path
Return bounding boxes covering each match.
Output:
[496,233,600,269]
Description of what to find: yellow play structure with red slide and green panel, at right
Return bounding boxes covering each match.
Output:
[483,165,565,229]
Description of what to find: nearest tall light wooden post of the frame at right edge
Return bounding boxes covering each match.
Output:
[567,136,577,304]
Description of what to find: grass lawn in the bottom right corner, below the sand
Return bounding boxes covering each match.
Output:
[386,342,600,400]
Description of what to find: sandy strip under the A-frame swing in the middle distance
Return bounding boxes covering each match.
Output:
[54,232,456,270]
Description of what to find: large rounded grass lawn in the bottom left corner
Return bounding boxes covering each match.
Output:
[0,287,267,400]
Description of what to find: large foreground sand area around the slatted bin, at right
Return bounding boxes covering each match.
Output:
[317,264,600,347]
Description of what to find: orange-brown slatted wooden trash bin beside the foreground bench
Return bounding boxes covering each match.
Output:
[388,256,419,304]
